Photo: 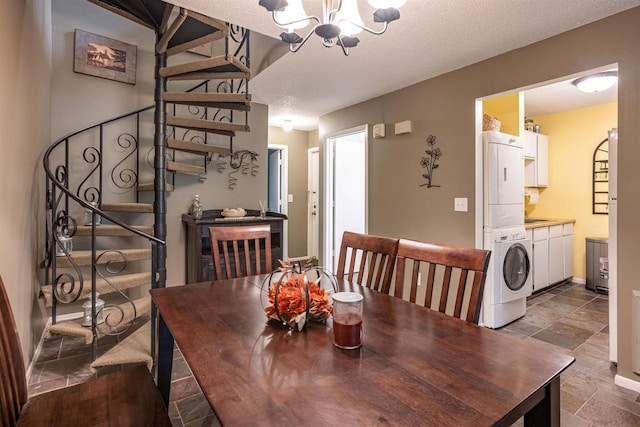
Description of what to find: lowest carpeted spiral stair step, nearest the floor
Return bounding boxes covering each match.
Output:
[91,321,153,372]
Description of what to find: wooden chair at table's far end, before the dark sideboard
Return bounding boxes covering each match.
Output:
[209,224,273,280]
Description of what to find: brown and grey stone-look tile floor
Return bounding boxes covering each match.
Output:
[29,283,640,427]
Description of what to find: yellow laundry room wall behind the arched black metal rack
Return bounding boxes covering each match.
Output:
[526,102,618,279]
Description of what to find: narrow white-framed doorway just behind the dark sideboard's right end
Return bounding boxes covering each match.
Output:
[267,144,289,259]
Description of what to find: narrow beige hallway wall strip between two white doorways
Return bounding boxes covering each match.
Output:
[269,126,309,258]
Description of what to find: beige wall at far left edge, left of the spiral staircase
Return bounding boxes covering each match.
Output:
[0,0,51,364]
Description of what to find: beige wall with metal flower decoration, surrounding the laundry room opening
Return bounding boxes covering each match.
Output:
[319,7,640,381]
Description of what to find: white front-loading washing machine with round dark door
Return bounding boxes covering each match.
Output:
[483,226,533,328]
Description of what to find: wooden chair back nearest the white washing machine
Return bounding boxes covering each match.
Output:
[393,239,491,324]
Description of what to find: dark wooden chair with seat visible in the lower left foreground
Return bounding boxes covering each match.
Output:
[0,277,171,427]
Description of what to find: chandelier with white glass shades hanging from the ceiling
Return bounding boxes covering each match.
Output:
[258,0,407,55]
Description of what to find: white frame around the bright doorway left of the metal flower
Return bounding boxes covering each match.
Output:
[322,124,369,268]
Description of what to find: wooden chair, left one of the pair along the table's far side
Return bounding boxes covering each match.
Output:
[336,231,398,293]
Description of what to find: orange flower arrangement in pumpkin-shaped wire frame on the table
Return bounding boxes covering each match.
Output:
[264,260,335,331]
